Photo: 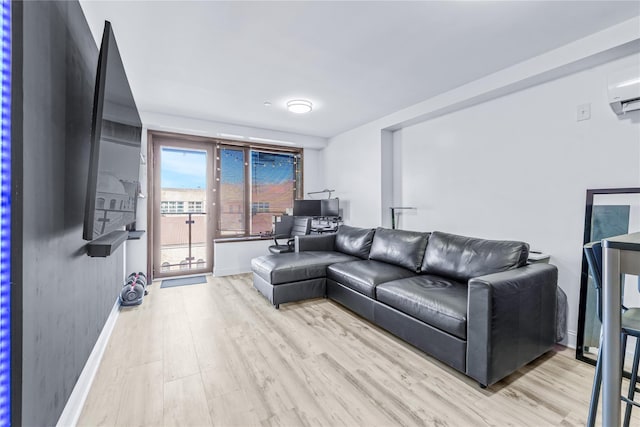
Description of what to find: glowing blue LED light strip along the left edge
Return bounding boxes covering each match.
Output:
[0,0,11,426]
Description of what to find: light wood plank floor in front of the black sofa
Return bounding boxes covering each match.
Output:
[79,275,640,426]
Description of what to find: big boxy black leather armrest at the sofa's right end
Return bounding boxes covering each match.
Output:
[467,264,558,386]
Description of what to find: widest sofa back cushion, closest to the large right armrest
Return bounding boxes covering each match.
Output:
[421,231,529,282]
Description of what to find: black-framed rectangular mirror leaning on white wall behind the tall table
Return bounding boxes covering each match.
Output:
[576,188,640,365]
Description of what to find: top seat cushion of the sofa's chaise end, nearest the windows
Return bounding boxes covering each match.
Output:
[251,251,358,285]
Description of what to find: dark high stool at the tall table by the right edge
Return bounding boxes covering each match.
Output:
[584,242,640,427]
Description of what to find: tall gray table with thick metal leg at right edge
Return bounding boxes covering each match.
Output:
[602,233,640,426]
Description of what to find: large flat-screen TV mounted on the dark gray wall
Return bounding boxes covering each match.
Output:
[82,21,142,240]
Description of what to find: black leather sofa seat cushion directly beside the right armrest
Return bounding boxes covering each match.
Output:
[376,275,467,340]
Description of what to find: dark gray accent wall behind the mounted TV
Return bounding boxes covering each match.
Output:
[13,1,124,426]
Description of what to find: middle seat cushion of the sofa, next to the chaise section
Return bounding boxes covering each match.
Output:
[327,260,415,298]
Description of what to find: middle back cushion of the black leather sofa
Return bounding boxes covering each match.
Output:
[369,228,429,273]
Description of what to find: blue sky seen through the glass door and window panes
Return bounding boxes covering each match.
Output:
[160,147,294,188]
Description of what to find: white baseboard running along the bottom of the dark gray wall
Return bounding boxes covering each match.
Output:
[56,299,120,427]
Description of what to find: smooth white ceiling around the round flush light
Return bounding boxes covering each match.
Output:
[81,1,640,137]
